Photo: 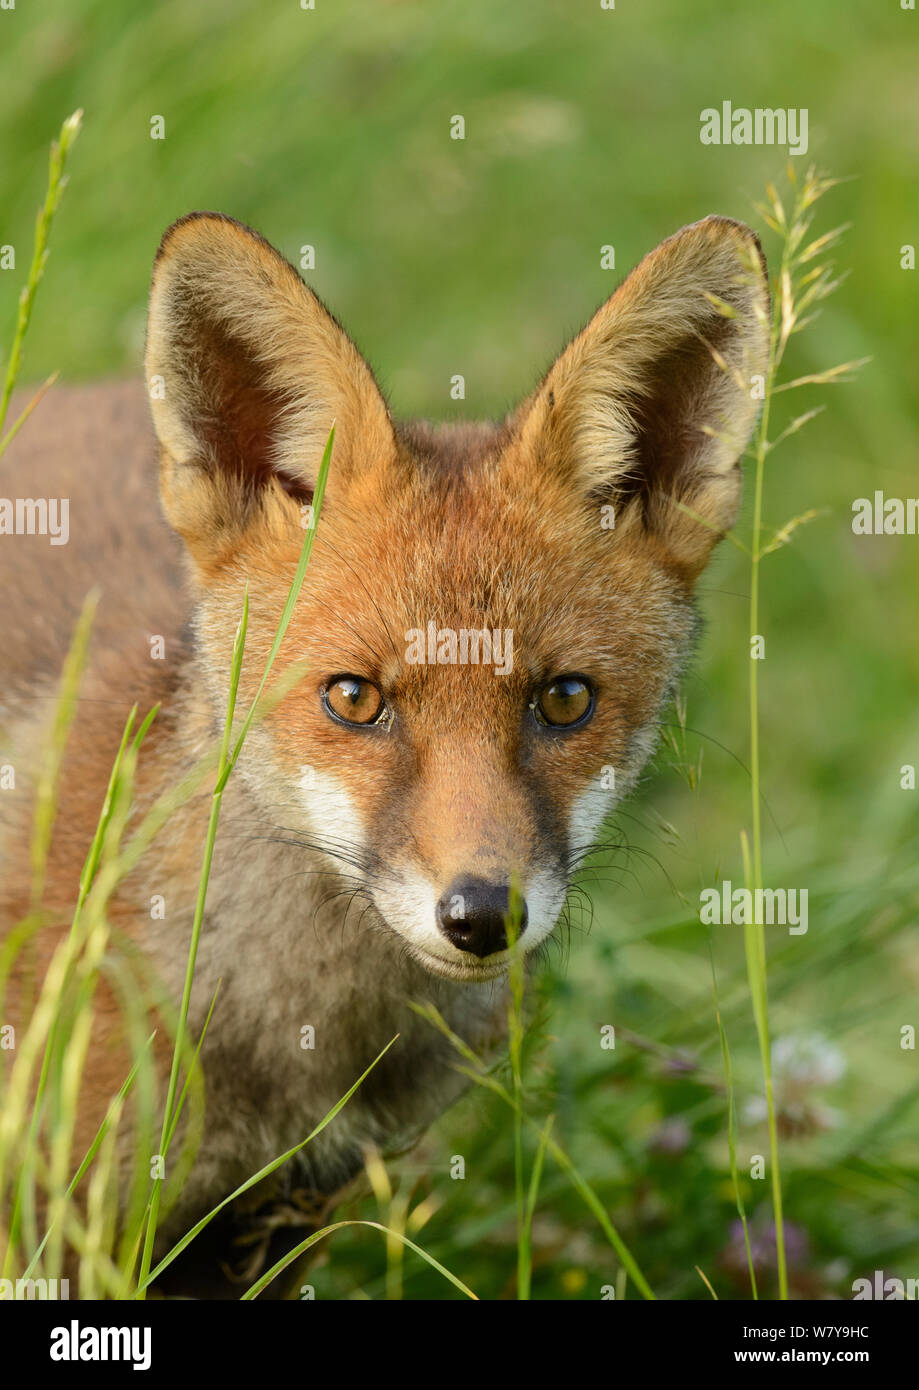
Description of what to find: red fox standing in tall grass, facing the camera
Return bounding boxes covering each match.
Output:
[0,213,769,1289]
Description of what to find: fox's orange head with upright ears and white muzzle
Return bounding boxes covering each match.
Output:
[146,214,769,980]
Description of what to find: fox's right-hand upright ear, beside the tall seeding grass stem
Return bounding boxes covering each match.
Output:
[521,217,769,580]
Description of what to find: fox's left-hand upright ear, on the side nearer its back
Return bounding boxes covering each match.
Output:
[146,213,393,563]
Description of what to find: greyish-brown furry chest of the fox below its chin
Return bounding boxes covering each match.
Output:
[143,834,503,1195]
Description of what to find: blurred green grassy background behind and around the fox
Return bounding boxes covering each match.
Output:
[0,0,919,1298]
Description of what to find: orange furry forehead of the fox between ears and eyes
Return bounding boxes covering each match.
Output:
[234,425,691,706]
